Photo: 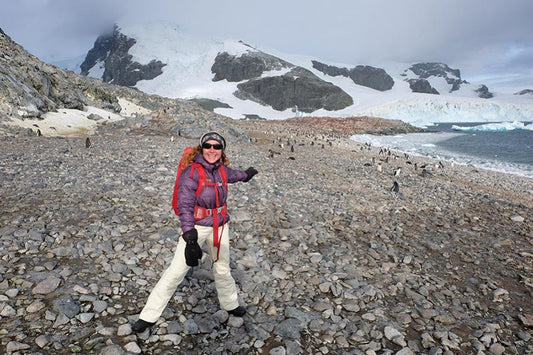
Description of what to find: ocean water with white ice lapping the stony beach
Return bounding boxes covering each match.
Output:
[352,122,533,178]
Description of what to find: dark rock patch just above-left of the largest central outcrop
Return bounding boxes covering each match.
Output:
[211,51,294,82]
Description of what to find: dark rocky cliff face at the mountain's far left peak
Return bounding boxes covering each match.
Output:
[82,26,166,87]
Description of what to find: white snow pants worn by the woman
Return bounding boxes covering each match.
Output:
[139,227,239,323]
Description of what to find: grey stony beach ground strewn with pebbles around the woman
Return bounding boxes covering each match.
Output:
[0,122,533,355]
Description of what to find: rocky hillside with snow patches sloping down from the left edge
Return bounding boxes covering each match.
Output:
[0,27,242,138]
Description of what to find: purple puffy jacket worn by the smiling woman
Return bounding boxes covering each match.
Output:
[178,154,247,233]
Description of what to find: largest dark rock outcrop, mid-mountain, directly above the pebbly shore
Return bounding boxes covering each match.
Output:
[234,67,353,112]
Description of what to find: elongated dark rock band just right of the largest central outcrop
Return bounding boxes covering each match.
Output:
[312,60,394,91]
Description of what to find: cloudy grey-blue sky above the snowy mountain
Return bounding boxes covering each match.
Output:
[0,0,533,89]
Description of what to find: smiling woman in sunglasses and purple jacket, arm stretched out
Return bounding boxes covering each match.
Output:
[132,132,257,333]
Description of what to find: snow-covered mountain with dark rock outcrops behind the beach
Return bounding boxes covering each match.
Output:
[81,23,533,126]
